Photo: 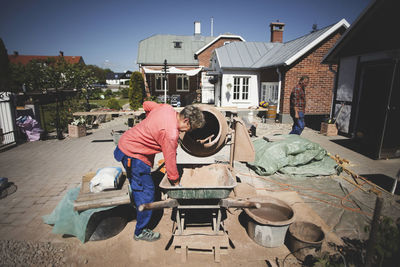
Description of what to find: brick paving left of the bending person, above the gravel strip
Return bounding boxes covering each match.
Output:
[0,117,127,242]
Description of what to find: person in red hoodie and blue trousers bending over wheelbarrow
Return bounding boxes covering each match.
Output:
[114,101,205,241]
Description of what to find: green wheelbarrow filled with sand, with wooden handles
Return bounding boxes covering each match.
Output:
[138,164,261,262]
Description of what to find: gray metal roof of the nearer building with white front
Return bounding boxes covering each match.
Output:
[215,23,340,69]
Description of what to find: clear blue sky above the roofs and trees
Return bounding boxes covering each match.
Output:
[0,0,371,72]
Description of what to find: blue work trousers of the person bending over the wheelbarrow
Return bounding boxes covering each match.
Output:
[114,146,154,236]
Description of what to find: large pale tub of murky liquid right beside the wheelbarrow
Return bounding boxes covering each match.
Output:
[245,198,294,248]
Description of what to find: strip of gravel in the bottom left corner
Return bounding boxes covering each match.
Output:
[0,240,69,266]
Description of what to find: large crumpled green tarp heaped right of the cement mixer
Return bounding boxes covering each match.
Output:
[248,135,337,176]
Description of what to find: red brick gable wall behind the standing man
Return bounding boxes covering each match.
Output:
[281,29,343,115]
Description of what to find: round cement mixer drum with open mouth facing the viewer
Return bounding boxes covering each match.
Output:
[179,105,228,157]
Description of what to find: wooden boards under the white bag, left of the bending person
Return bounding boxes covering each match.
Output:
[74,172,131,211]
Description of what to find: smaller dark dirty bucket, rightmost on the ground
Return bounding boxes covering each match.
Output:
[287,222,325,261]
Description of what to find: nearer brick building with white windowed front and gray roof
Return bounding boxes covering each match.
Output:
[210,19,349,125]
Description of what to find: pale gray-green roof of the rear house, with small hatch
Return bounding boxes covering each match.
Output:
[137,34,216,65]
